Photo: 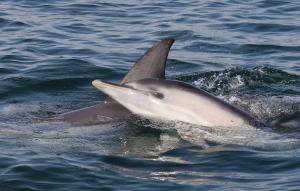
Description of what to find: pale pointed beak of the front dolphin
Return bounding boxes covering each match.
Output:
[92,80,131,95]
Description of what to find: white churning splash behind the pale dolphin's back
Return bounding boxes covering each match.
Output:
[188,67,300,122]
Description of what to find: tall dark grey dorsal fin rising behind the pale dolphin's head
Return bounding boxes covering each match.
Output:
[121,39,174,84]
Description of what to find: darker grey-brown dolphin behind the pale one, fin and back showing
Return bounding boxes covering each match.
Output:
[61,38,174,125]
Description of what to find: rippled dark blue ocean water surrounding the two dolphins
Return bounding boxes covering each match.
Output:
[0,0,300,191]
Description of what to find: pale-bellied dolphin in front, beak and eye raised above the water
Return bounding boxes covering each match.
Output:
[92,78,264,127]
